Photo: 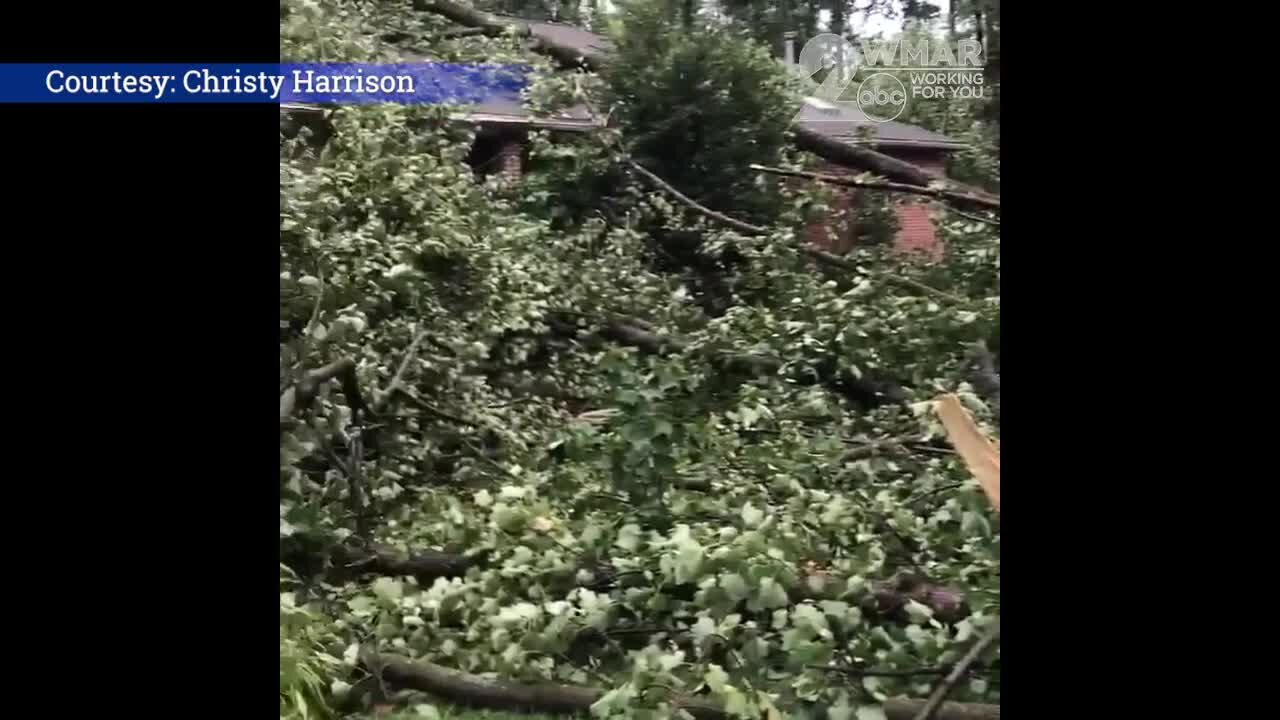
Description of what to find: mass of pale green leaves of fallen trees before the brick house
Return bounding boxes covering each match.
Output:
[280,0,1000,720]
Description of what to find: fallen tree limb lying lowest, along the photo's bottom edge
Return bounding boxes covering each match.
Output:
[361,651,1000,720]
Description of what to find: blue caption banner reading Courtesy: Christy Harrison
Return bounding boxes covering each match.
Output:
[0,63,530,105]
